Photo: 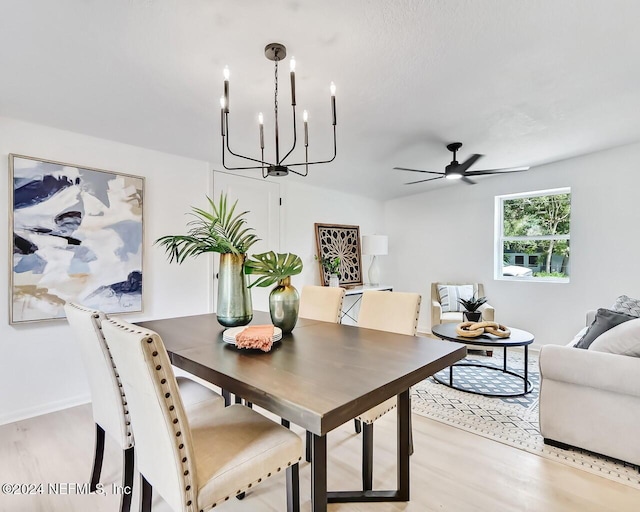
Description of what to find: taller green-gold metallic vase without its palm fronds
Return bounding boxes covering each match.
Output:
[216,253,253,327]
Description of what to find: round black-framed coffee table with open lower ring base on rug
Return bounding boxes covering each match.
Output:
[431,323,533,397]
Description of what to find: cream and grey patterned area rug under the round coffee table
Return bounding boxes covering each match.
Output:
[411,350,640,489]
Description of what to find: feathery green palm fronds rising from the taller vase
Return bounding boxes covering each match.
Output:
[155,193,259,263]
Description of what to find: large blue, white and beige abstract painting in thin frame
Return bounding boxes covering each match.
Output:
[9,154,144,324]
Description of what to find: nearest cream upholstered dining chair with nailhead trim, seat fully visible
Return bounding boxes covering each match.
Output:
[102,318,302,512]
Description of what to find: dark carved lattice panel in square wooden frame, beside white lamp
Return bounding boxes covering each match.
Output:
[314,223,362,286]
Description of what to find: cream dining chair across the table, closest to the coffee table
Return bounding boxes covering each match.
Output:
[356,290,421,491]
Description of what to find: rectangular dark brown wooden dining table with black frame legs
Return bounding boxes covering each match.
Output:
[136,311,466,512]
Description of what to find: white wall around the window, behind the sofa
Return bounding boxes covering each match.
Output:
[385,144,640,344]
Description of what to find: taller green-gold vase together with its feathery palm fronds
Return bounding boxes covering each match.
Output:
[155,193,259,327]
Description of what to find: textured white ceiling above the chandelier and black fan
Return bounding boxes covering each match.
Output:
[0,0,640,198]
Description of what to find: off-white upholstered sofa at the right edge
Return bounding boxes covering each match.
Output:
[539,310,640,469]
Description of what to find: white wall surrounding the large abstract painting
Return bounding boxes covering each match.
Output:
[0,118,212,424]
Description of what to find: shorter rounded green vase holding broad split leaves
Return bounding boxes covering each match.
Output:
[244,251,303,334]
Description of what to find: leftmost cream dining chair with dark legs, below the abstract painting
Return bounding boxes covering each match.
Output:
[64,303,224,512]
